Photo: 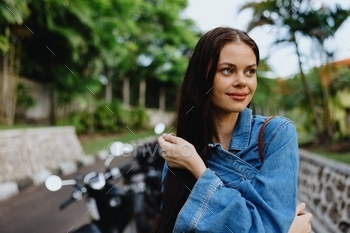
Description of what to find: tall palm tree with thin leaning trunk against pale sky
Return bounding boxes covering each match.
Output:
[241,0,349,140]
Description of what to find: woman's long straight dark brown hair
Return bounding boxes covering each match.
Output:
[151,27,259,233]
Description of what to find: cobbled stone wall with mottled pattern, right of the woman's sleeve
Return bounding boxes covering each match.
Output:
[299,150,350,233]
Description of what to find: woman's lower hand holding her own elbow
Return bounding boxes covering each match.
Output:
[288,203,313,233]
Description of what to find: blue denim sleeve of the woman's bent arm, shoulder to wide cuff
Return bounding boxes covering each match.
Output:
[174,121,299,233]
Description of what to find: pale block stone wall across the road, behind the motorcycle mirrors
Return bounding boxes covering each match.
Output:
[0,126,84,183]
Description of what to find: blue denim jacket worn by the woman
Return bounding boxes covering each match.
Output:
[163,108,299,233]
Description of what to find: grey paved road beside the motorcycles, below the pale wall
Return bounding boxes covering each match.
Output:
[0,155,138,233]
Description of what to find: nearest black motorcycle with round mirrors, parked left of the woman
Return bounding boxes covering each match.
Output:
[45,142,150,233]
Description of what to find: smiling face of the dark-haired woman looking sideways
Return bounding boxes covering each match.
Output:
[211,42,257,113]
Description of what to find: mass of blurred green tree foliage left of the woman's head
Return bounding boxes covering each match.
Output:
[0,0,201,124]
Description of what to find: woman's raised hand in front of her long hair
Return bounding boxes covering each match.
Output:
[158,134,207,179]
